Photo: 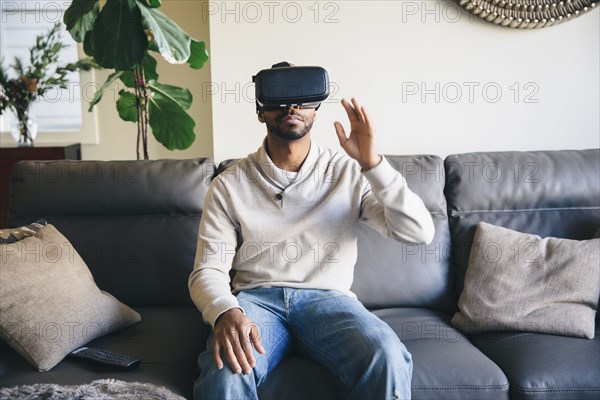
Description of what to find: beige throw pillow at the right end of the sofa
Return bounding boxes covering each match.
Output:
[452,222,600,339]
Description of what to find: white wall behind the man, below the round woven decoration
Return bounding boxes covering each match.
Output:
[207,0,600,161]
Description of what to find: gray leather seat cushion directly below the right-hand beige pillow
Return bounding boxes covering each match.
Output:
[471,326,600,400]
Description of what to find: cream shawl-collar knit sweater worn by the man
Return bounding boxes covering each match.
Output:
[189,143,434,326]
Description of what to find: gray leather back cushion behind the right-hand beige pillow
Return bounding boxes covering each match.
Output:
[445,149,600,293]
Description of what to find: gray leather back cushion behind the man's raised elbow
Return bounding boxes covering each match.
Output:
[352,155,456,311]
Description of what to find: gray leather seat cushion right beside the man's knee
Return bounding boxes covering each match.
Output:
[374,308,508,400]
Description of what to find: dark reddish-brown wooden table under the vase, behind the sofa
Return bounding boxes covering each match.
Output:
[0,143,81,228]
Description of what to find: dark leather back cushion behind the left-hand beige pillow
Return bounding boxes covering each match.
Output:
[9,159,215,306]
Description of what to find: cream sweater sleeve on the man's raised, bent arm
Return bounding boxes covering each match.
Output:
[361,157,435,244]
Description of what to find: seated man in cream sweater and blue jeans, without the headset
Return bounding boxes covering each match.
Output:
[189,64,434,399]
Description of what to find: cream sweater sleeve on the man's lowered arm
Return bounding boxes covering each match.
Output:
[188,179,240,328]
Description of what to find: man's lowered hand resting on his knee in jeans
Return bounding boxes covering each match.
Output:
[213,308,265,374]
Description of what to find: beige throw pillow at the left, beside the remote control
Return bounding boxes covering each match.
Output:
[0,225,140,371]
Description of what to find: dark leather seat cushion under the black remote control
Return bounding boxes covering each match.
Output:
[0,307,207,397]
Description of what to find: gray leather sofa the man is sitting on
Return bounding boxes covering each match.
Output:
[0,149,600,400]
